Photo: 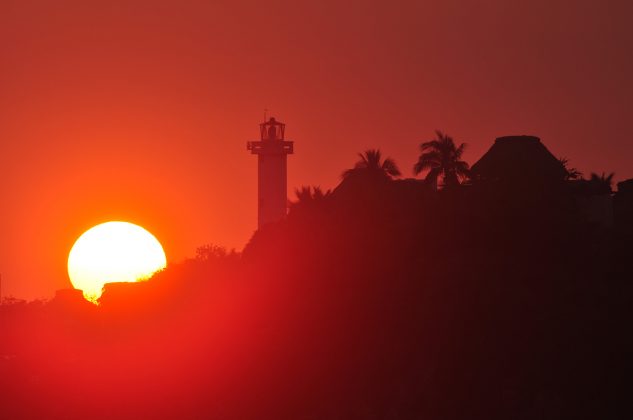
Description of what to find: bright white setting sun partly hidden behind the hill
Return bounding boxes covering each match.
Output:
[68,222,167,302]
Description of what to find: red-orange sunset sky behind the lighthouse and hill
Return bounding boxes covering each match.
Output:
[0,0,633,299]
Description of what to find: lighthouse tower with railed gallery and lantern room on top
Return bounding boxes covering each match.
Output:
[246,117,293,228]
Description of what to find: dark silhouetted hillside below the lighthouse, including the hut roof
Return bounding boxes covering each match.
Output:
[0,137,633,419]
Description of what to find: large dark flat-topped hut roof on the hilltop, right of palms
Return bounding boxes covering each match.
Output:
[471,136,567,181]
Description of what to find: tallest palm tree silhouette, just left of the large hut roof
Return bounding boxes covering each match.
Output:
[413,130,469,189]
